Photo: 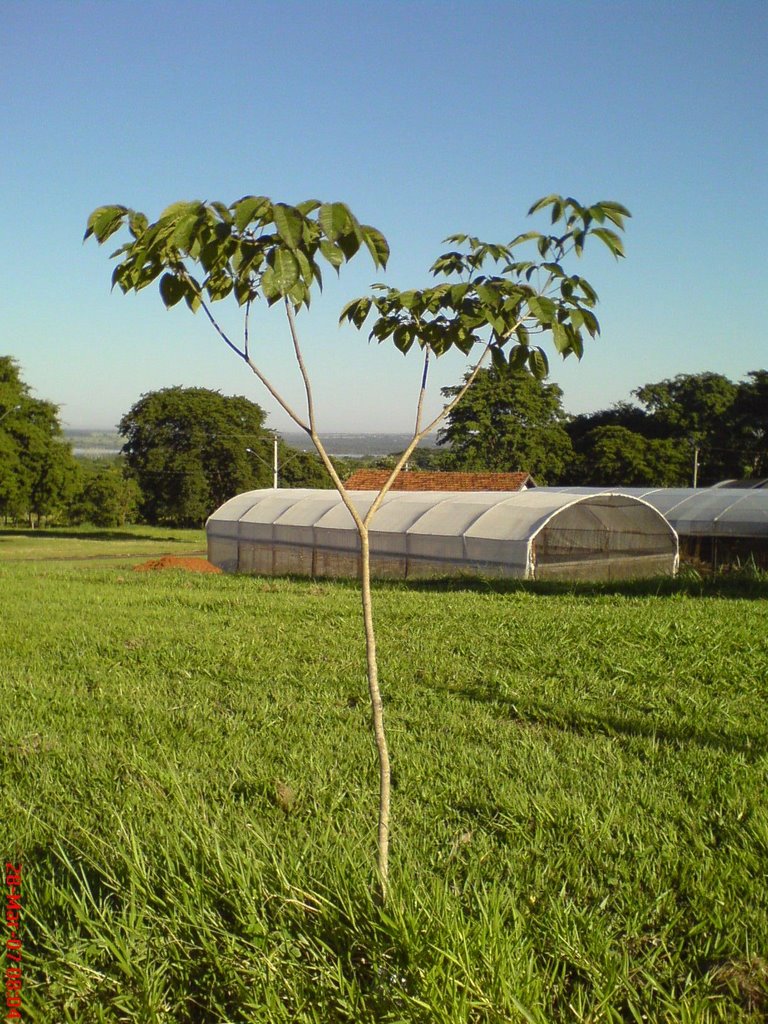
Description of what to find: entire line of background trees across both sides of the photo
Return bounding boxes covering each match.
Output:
[0,356,768,527]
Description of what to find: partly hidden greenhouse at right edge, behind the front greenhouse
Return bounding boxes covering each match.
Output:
[542,481,768,567]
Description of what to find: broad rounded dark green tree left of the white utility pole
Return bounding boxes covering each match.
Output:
[119,387,272,526]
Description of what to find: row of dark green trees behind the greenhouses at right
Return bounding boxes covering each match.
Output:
[430,366,768,486]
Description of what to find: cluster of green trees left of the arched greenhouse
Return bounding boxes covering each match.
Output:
[0,356,328,526]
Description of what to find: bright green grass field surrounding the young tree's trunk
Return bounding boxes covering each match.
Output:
[0,528,768,1024]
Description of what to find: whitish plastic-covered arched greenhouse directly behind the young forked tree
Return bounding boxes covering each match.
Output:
[206,488,678,580]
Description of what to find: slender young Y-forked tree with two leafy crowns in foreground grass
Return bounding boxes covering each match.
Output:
[85,195,629,899]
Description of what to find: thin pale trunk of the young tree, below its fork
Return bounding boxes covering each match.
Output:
[359,527,391,903]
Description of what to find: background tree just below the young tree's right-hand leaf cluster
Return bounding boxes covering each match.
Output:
[437,362,573,483]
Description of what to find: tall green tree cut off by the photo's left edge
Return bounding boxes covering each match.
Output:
[0,355,78,523]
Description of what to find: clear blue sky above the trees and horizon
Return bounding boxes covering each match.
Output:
[0,0,768,432]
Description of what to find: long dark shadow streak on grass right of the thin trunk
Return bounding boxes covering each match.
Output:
[434,686,768,761]
